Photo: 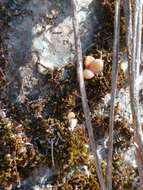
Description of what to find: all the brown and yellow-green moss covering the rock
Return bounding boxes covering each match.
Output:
[0,1,137,190]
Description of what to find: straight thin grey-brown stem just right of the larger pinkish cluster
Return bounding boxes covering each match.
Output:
[107,0,120,190]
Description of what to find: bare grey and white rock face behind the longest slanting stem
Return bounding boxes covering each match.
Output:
[1,0,101,102]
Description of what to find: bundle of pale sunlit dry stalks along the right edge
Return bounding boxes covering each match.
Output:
[124,0,143,189]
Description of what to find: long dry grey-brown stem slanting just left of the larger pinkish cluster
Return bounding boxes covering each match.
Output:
[71,0,106,190]
